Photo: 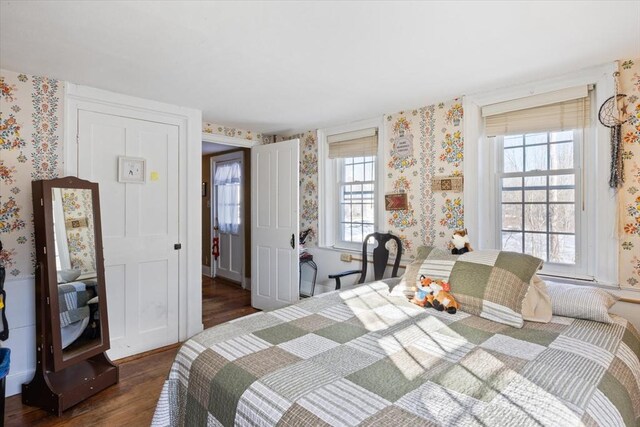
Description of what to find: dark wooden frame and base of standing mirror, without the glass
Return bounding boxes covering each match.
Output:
[22,177,119,415]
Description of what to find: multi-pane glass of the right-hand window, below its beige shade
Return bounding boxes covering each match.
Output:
[496,130,582,269]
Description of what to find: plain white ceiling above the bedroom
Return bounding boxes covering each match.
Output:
[0,1,640,133]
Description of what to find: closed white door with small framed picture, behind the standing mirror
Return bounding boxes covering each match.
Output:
[78,110,179,359]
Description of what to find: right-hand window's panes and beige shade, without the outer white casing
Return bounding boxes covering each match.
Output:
[483,89,590,277]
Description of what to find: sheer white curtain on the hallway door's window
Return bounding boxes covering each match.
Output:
[213,161,242,234]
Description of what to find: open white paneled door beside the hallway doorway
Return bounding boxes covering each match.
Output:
[251,139,300,310]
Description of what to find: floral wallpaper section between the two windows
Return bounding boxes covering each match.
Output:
[384,99,464,259]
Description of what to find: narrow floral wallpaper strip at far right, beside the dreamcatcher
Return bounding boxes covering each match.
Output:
[618,58,640,289]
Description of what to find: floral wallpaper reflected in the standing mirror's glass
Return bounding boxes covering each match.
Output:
[61,188,96,275]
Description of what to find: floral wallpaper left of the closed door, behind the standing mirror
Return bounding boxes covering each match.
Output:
[0,70,64,278]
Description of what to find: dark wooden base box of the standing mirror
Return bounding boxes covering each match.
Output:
[22,353,119,416]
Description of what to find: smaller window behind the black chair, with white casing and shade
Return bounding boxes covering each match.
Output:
[318,117,384,251]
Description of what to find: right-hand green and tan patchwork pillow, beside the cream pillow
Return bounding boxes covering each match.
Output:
[449,250,542,328]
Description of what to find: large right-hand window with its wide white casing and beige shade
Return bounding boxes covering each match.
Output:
[463,63,619,286]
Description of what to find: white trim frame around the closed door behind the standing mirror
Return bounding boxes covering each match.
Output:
[63,83,203,341]
